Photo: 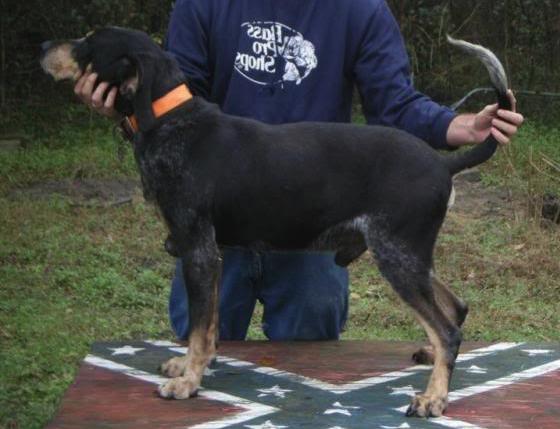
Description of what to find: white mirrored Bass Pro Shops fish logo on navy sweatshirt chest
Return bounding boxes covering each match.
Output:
[234,21,318,86]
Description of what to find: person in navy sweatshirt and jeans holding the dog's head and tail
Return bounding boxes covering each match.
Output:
[75,0,523,340]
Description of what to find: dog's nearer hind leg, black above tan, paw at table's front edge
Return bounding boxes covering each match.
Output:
[370,230,461,417]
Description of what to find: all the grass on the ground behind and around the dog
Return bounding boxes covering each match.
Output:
[0,107,560,429]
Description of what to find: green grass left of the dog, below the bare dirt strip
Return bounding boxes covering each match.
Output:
[0,199,171,428]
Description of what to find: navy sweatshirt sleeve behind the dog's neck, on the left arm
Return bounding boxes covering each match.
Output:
[165,0,211,98]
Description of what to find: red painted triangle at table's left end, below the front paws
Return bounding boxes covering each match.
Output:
[47,364,240,429]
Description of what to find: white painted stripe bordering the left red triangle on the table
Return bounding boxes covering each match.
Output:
[84,355,279,429]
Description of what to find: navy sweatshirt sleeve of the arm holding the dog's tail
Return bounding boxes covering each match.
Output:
[354,1,455,149]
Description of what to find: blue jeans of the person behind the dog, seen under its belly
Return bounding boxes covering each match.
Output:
[169,248,348,340]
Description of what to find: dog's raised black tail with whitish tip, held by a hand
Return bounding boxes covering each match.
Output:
[444,36,512,175]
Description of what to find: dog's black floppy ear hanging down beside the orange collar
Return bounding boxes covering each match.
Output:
[128,54,156,131]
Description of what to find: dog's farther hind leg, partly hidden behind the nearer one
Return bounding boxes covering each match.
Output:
[412,272,469,365]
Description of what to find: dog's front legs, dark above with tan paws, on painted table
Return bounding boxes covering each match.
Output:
[159,222,221,399]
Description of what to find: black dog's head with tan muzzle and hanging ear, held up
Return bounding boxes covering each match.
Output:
[40,27,184,130]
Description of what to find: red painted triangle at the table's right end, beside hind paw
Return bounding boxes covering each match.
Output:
[445,371,560,429]
